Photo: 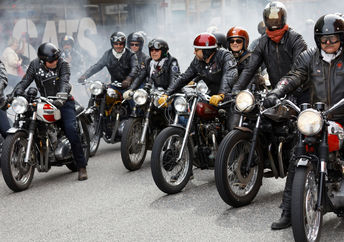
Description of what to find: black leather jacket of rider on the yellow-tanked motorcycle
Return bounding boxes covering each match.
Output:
[83,48,138,82]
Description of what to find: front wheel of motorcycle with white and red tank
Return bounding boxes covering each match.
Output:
[1,132,36,192]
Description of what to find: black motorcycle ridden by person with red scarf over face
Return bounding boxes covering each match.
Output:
[215,86,299,207]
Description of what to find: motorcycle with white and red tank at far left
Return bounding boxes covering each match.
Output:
[1,87,89,192]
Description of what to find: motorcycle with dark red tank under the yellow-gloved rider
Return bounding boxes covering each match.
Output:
[151,81,230,194]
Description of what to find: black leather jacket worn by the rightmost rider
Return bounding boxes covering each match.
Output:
[272,48,344,118]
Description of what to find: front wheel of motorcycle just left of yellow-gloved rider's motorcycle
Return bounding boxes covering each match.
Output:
[121,118,148,171]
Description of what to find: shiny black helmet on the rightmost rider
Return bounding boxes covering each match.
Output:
[314,14,344,49]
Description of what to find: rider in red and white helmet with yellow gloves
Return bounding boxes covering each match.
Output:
[159,33,238,106]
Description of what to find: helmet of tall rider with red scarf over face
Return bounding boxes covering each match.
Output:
[263,1,287,31]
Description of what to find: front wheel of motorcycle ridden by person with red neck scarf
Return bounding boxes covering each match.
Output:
[215,130,264,207]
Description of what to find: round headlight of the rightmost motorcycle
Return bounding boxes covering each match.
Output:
[297,108,324,136]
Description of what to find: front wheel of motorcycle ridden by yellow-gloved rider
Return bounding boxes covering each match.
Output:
[151,127,193,194]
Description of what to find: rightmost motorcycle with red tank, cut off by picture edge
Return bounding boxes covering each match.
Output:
[291,99,344,241]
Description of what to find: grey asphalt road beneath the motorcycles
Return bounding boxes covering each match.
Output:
[0,143,344,242]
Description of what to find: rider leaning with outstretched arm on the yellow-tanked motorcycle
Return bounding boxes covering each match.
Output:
[78,32,138,90]
